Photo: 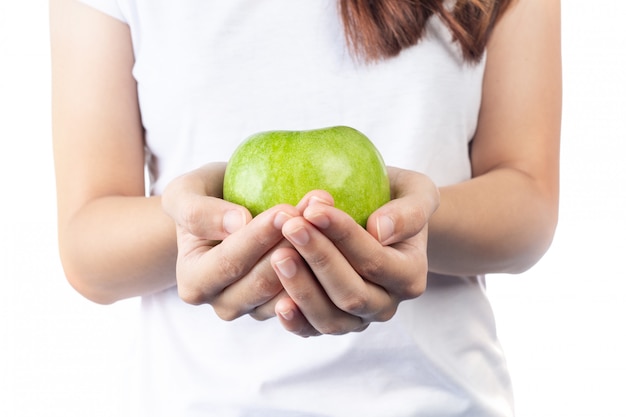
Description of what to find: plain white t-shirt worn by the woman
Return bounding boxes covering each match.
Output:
[77,0,513,417]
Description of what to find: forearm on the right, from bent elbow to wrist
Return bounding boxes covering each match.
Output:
[428,168,558,275]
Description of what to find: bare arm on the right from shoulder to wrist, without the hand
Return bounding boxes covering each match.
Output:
[428,0,561,275]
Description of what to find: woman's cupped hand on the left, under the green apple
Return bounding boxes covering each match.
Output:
[162,163,299,320]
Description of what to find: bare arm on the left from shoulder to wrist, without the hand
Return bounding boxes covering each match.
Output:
[50,0,176,303]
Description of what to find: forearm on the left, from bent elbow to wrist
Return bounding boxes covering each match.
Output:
[59,193,177,304]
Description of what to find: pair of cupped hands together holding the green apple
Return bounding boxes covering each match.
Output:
[162,164,439,336]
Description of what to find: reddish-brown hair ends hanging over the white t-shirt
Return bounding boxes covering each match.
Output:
[339,0,512,62]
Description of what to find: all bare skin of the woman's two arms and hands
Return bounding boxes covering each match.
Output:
[50,0,561,336]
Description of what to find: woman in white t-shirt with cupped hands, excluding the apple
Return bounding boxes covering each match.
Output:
[51,0,561,416]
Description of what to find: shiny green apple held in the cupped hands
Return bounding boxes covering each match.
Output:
[224,126,390,227]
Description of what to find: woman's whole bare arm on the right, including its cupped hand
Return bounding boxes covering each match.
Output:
[264,0,561,336]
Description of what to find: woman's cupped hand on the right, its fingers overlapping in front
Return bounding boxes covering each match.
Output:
[271,168,439,337]
